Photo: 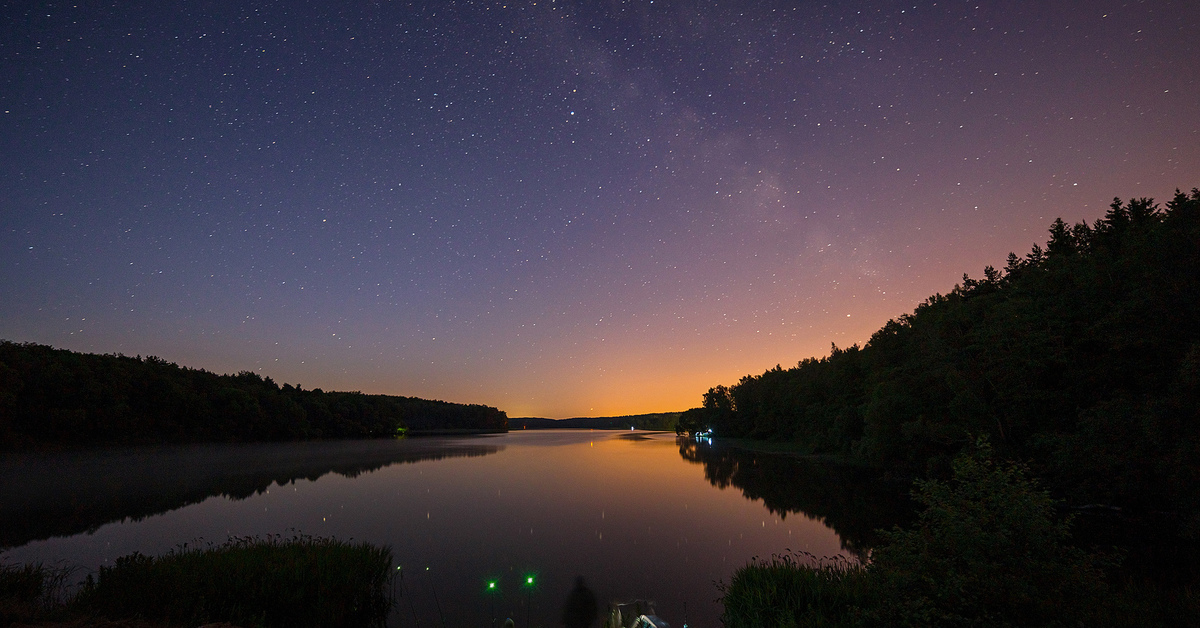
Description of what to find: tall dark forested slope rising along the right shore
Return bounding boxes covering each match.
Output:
[680,189,1200,538]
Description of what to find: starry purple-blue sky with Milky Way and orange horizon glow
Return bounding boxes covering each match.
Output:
[0,0,1200,417]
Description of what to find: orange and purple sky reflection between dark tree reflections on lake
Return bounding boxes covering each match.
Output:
[5,431,841,626]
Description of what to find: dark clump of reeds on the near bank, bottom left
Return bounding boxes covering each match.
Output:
[0,537,392,628]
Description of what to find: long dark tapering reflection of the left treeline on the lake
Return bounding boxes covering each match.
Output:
[0,438,503,548]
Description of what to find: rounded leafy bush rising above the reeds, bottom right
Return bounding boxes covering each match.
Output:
[865,442,1110,627]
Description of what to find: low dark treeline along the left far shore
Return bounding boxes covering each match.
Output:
[0,341,508,447]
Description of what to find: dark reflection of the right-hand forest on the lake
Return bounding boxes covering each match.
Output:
[678,438,912,555]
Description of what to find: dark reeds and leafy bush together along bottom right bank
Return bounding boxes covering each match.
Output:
[722,442,1200,628]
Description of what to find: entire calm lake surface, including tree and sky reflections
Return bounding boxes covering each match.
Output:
[0,430,905,628]
